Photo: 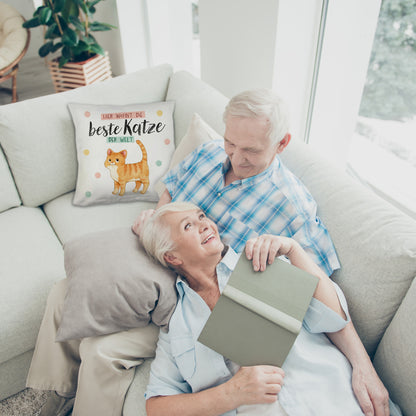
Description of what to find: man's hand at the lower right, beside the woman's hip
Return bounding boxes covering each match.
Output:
[352,366,390,416]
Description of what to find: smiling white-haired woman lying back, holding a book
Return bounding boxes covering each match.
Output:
[141,202,400,416]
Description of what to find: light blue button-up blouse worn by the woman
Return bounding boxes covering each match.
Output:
[145,248,398,416]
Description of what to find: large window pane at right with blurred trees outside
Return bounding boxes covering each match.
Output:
[348,0,416,218]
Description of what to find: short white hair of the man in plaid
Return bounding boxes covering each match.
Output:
[223,89,289,144]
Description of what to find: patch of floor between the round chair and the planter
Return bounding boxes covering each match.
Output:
[0,56,55,105]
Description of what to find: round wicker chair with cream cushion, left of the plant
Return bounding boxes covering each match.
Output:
[0,2,30,102]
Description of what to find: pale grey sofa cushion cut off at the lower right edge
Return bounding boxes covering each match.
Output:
[374,278,416,415]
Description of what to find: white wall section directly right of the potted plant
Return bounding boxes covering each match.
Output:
[111,0,193,73]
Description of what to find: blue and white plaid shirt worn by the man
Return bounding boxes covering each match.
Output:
[163,140,339,275]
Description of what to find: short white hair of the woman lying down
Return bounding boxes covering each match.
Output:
[140,202,199,267]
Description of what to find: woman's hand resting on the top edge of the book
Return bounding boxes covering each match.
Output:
[245,234,298,272]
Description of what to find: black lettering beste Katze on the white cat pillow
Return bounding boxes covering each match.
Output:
[88,119,166,137]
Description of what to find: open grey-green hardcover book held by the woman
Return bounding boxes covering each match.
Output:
[198,253,319,367]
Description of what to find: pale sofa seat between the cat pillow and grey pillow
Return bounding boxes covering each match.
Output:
[43,192,156,244]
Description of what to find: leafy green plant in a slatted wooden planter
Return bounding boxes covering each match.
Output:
[23,0,115,92]
